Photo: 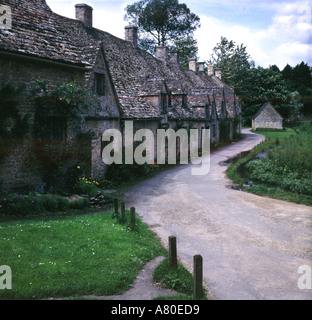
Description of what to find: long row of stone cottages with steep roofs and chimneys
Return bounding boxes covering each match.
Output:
[0,0,241,191]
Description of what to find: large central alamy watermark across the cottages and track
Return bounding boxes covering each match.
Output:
[102,121,210,175]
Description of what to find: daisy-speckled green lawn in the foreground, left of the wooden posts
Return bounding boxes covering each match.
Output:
[0,213,166,299]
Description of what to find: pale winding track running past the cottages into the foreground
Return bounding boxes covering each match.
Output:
[124,131,312,299]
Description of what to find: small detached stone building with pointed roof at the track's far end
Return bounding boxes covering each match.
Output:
[252,102,283,130]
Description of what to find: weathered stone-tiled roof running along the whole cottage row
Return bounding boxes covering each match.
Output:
[0,0,240,119]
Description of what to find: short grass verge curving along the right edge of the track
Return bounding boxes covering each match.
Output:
[227,128,312,206]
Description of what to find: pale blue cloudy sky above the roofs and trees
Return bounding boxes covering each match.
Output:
[46,0,312,70]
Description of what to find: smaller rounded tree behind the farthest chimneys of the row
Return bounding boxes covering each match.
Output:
[208,37,254,95]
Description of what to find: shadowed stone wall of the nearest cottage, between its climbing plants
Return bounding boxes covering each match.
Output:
[0,56,84,192]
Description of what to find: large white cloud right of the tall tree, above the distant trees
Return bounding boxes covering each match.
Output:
[195,0,312,69]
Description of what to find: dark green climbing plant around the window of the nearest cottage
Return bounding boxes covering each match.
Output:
[33,80,97,191]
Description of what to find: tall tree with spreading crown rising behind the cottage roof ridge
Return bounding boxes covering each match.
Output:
[125,0,200,48]
